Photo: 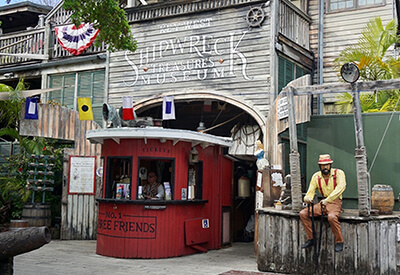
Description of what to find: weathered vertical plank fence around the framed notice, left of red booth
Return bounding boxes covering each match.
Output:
[20,104,101,240]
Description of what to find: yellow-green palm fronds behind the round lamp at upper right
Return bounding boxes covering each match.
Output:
[334,17,400,113]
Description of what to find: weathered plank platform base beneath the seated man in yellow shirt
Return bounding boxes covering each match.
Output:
[257,208,400,275]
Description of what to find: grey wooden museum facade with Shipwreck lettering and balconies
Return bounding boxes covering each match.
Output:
[0,0,313,242]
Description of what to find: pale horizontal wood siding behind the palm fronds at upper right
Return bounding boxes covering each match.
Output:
[309,0,393,102]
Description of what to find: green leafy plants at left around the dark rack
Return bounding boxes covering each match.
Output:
[0,79,68,222]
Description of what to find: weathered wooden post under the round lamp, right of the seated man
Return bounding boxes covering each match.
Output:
[351,83,370,217]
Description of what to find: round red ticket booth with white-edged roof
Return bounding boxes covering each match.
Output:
[87,127,233,258]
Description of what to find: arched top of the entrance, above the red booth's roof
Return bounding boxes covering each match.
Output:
[133,91,266,136]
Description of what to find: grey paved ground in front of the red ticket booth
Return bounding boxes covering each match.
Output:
[14,240,278,275]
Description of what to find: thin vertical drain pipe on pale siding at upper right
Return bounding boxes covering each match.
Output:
[317,0,324,115]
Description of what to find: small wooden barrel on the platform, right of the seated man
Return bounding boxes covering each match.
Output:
[371,184,394,214]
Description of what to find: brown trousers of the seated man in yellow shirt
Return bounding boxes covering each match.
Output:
[300,199,343,243]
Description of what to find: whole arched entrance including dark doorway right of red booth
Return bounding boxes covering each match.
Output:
[134,91,266,245]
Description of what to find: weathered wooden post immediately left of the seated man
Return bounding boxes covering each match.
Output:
[286,87,303,213]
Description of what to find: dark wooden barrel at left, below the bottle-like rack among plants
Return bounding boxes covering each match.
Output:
[22,203,51,227]
